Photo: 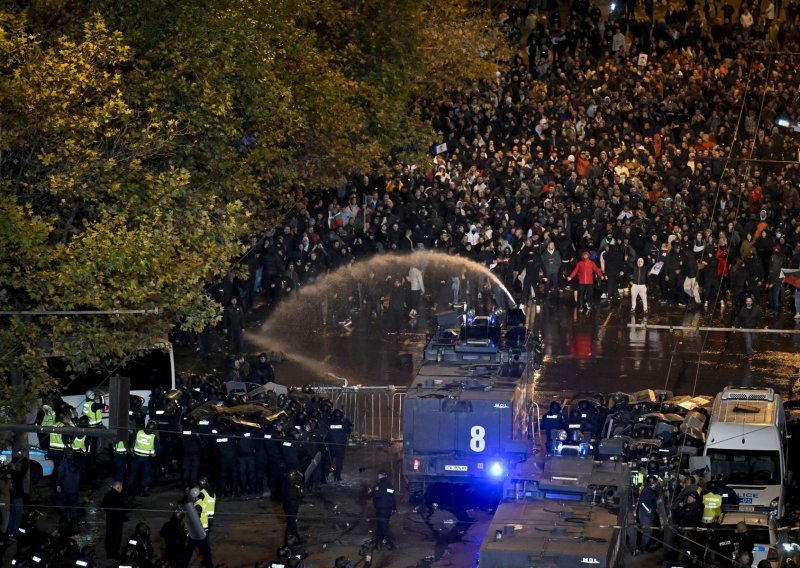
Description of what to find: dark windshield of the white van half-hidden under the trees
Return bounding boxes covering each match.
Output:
[47,349,172,396]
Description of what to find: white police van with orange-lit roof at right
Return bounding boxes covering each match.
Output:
[703,387,789,518]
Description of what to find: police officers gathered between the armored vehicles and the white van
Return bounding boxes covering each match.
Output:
[541,393,772,568]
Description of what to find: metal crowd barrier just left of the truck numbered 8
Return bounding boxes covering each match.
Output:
[314,385,408,442]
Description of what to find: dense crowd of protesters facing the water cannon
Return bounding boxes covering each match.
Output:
[212,0,800,332]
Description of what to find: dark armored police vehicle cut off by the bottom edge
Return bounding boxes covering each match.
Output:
[479,443,631,568]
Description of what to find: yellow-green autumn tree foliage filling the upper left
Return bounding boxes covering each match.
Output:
[0,0,508,414]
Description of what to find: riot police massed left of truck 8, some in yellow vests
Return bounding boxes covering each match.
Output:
[17,377,376,566]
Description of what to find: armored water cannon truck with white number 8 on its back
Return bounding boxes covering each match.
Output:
[403,309,536,499]
